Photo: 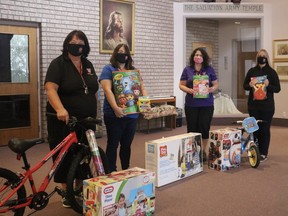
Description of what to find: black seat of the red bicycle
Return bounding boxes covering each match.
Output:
[8,138,44,154]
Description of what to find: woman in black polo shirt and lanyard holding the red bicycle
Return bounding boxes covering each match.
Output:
[45,30,99,207]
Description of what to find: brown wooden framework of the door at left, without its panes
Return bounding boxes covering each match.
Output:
[0,21,41,146]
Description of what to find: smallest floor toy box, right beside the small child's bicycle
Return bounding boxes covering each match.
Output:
[208,128,241,171]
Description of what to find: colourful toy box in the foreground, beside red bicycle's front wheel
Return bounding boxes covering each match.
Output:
[83,167,155,216]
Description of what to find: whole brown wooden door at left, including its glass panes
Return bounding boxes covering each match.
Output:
[0,25,40,146]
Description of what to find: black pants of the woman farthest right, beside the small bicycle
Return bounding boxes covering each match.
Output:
[248,109,275,155]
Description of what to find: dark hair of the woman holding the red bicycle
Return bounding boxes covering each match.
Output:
[62,30,90,58]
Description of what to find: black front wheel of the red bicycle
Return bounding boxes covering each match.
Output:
[67,147,109,214]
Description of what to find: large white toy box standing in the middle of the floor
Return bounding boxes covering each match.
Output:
[145,133,203,187]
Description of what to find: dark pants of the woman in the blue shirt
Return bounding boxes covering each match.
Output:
[104,115,137,172]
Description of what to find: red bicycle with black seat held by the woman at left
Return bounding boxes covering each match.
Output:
[0,113,109,216]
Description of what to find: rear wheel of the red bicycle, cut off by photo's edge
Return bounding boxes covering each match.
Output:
[0,168,26,216]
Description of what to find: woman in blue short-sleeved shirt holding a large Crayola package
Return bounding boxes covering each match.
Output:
[99,44,146,172]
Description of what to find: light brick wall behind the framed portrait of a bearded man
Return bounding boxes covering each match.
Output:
[0,0,202,137]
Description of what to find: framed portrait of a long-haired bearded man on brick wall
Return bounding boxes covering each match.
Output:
[100,0,135,54]
